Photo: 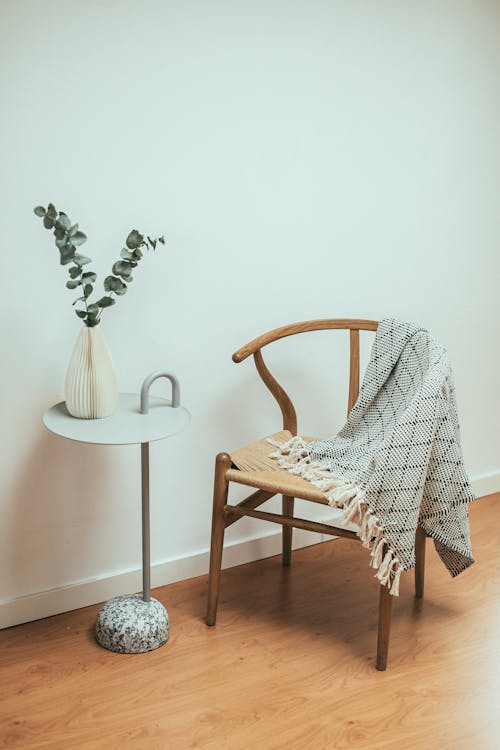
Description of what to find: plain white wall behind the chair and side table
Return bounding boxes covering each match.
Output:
[0,0,500,616]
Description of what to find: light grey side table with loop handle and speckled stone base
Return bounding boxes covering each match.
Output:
[43,371,191,654]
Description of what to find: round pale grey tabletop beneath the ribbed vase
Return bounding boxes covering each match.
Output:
[43,393,191,445]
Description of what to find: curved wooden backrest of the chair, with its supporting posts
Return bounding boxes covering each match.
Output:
[233,318,378,435]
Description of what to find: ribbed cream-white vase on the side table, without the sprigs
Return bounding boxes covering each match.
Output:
[64,326,118,419]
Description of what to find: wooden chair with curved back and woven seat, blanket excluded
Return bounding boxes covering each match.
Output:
[207,319,426,671]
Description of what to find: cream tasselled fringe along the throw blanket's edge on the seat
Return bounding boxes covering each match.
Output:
[267,435,403,596]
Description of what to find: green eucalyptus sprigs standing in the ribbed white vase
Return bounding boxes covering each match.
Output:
[34,203,165,328]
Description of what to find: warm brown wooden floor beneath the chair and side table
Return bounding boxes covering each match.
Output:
[0,495,500,750]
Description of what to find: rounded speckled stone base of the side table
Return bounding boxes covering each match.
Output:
[95,594,168,654]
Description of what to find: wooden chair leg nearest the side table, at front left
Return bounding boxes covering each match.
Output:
[207,453,231,625]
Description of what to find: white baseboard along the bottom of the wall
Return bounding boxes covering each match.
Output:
[0,471,500,629]
